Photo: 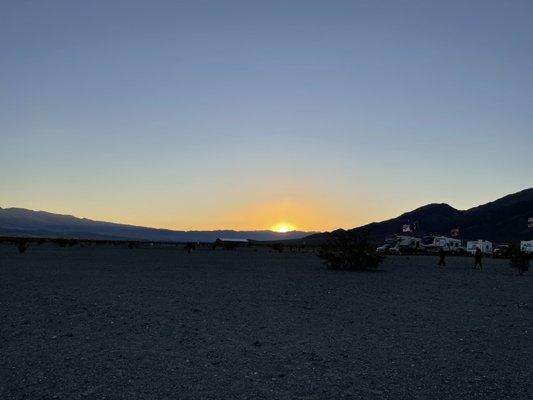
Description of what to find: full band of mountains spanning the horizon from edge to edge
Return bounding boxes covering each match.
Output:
[0,188,533,244]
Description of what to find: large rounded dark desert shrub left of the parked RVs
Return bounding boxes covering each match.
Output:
[318,233,383,271]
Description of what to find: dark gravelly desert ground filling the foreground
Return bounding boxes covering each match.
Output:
[0,245,533,400]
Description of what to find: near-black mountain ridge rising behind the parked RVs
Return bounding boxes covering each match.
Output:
[305,188,533,244]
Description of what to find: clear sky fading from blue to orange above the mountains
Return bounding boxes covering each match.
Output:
[0,0,533,231]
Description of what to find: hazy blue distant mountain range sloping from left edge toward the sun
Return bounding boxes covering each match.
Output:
[0,208,313,242]
